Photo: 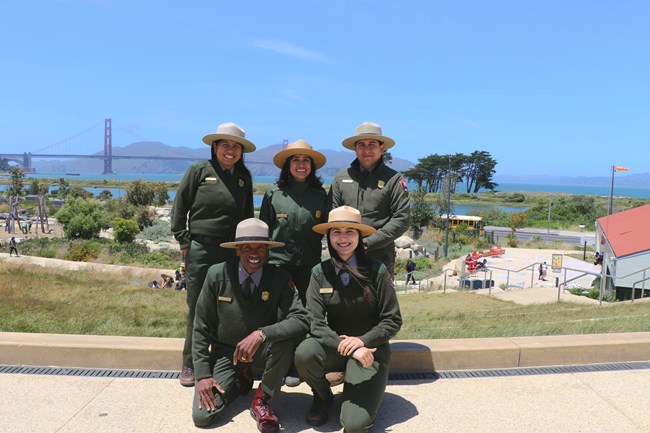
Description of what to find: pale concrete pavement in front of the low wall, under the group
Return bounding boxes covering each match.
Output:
[0,370,650,433]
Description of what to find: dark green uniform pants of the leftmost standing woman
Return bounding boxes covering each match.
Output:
[183,240,235,368]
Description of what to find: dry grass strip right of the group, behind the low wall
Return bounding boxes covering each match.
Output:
[397,292,650,339]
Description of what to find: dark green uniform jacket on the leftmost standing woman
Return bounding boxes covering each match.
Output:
[171,159,253,249]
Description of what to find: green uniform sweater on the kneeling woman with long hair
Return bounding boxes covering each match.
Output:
[307,258,402,350]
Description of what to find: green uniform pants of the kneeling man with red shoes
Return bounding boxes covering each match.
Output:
[192,339,296,427]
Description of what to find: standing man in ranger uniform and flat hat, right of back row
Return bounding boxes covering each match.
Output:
[330,122,411,276]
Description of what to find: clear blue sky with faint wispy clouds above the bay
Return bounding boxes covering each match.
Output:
[0,0,650,176]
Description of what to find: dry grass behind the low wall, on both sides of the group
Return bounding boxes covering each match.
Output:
[0,261,650,339]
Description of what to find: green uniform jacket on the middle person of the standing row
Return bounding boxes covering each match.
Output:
[260,182,329,268]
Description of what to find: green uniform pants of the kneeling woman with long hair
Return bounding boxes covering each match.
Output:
[295,338,390,433]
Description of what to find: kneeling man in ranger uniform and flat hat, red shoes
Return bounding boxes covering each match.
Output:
[192,218,309,433]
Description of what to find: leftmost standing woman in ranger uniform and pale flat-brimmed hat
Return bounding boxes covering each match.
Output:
[171,122,255,386]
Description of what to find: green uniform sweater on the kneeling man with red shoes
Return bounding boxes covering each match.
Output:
[192,257,309,379]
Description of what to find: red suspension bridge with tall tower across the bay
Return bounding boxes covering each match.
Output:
[0,119,276,174]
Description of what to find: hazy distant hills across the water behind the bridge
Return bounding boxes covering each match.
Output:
[34,141,415,177]
